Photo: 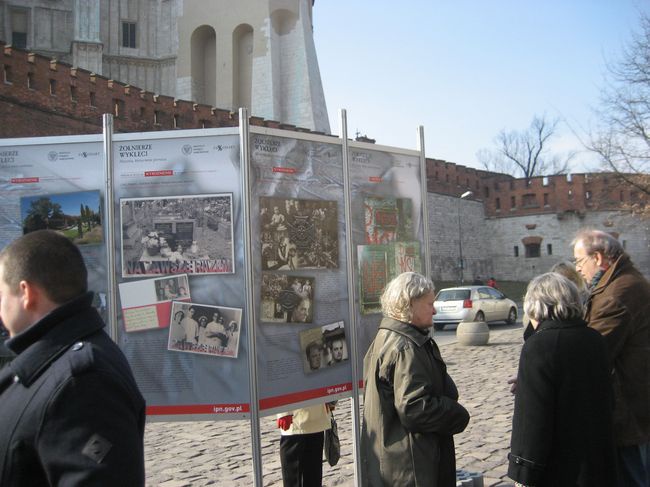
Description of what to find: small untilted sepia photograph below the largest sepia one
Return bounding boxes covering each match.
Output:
[260,272,314,323]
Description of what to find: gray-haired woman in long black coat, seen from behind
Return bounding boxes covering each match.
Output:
[508,272,616,487]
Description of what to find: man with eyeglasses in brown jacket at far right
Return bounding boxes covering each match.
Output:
[572,230,650,487]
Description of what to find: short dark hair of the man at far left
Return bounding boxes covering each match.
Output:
[0,230,88,304]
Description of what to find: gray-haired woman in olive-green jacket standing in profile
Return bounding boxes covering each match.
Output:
[361,272,469,487]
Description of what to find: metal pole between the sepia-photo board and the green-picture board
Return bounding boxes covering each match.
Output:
[341,109,363,487]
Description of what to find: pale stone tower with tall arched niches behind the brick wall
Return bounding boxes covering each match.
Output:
[176,0,330,133]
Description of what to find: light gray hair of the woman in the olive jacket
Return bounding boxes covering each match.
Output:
[381,272,436,323]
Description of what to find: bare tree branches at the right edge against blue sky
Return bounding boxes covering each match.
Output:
[587,14,650,203]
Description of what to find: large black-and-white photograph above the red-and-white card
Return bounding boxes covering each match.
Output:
[120,193,235,277]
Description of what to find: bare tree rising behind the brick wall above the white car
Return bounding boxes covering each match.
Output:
[476,115,575,179]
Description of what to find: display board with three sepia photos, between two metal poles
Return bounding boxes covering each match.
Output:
[250,127,352,414]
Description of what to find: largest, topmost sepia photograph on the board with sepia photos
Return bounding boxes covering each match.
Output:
[260,197,339,270]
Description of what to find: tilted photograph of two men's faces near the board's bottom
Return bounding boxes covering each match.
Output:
[300,321,348,374]
